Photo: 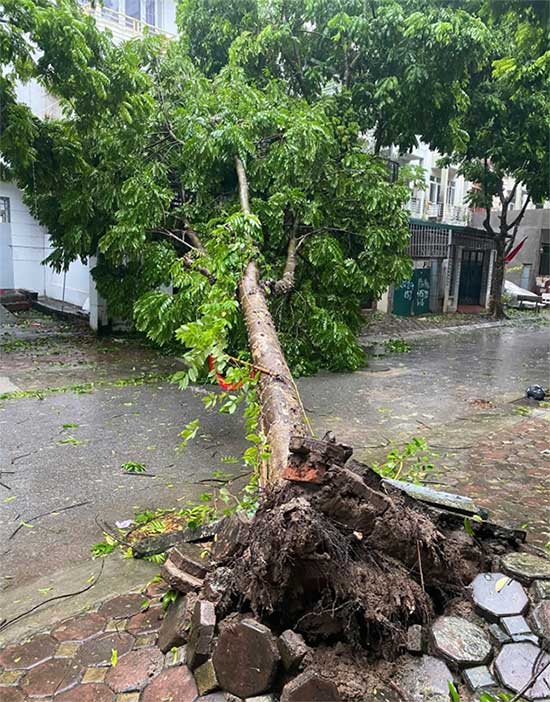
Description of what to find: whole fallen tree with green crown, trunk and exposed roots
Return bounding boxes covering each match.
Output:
[0,0,548,700]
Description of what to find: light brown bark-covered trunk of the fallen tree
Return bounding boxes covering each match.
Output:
[236,158,308,487]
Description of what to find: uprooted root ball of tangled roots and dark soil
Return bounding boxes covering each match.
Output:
[209,467,482,656]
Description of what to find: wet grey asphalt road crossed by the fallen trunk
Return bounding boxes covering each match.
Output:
[0,327,550,583]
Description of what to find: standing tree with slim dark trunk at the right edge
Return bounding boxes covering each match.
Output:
[444,0,550,319]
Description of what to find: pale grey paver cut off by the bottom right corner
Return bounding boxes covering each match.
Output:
[495,643,550,700]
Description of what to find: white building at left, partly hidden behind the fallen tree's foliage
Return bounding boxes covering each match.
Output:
[0,0,176,327]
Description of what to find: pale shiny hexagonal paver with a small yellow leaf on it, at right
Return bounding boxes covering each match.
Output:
[470,573,529,622]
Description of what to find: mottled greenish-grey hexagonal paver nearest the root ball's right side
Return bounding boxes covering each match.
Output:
[432,617,492,668]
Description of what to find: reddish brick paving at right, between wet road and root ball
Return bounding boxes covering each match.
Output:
[360,403,550,547]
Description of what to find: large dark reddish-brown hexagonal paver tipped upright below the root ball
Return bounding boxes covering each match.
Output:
[212,619,281,697]
